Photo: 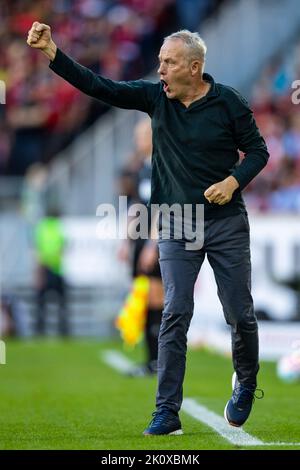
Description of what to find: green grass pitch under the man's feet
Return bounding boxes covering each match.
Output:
[0,339,300,450]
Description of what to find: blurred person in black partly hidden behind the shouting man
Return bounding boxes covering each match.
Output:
[119,118,163,376]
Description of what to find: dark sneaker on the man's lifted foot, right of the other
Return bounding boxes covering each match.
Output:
[224,373,264,427]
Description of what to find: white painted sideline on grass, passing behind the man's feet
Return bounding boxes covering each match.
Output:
[99,349,300,447]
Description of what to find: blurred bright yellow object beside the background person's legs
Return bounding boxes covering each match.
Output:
[116,275,150,346]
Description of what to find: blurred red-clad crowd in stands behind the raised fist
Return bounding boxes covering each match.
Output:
[0,0,221,175]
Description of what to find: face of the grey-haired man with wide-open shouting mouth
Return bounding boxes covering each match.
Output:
[158,39,193,100]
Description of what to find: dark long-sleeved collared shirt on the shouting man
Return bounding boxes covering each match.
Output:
[50,49,269,219]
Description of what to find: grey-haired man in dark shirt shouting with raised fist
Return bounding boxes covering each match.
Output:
[27,22,269,435]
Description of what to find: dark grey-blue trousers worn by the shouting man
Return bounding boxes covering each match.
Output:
[156,213,259,411]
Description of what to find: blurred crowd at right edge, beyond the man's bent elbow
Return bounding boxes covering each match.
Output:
[245,38,300,212]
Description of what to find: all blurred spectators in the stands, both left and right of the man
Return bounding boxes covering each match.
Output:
[0,0,300,212]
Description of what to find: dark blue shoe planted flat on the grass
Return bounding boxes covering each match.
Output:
[143,408,183,436]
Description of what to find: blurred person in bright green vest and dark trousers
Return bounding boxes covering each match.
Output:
[35,208,69,336]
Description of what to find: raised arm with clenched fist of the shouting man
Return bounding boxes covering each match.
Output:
[27,21,160,116]
